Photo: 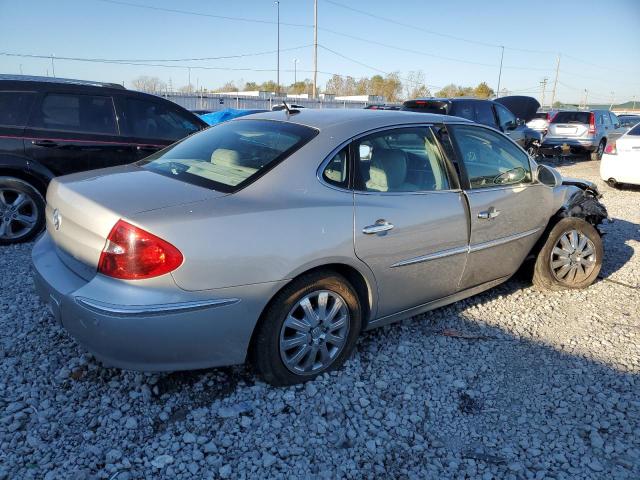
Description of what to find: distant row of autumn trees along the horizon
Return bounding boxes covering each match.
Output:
[131,71,495,102]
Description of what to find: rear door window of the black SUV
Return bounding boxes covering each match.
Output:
[30,93,117,135]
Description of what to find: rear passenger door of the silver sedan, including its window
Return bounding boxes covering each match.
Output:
[352,127,467,317]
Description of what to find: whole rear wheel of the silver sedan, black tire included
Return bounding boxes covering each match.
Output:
[250,270,362,386]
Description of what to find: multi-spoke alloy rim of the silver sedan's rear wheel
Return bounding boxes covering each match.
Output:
[279,290,351,375]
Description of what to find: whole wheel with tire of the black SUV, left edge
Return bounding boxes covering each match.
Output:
[0,177,45,245]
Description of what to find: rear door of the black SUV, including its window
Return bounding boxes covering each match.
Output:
[25,92,128,175]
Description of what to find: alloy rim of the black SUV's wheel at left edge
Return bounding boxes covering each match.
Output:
[0,187,38,240]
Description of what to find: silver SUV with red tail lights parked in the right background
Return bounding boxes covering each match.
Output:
[541,110,624,160]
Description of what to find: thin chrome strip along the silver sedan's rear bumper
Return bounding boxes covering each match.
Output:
[75,297,240,316]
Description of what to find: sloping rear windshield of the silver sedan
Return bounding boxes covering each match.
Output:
[138,120,318,192]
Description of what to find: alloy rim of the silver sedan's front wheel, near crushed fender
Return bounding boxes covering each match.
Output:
[550,230,596,285]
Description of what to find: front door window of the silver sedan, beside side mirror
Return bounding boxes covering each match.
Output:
[452,125,531,189]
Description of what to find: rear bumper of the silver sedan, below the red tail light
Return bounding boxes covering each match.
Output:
[32,233,284,371]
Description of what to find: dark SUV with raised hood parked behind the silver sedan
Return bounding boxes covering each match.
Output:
[401,96,542,158]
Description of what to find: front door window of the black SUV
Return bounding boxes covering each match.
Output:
[125,98,200,140]
